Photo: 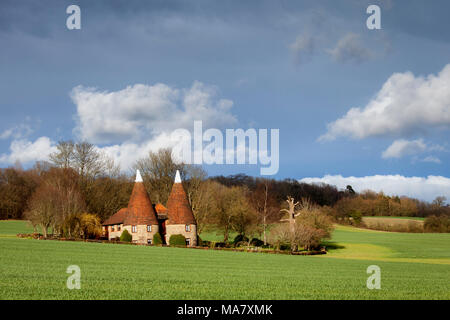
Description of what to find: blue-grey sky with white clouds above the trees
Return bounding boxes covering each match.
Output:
[0,0,450,201]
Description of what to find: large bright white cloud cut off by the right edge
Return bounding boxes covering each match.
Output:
[319,64,450,140]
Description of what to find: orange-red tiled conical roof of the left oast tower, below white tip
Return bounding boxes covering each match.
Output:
[123,182,158,225]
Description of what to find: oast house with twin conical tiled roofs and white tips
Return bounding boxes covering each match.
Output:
[103,170,197,246]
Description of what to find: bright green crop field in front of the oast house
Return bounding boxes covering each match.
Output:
[0,221,450,299]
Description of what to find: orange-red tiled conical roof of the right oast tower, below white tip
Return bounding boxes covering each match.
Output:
[166,182,196,224]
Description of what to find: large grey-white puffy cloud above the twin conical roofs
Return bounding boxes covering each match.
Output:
[72,82,236,143]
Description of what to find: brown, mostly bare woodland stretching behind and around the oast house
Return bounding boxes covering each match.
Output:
[0,141,450,247]
